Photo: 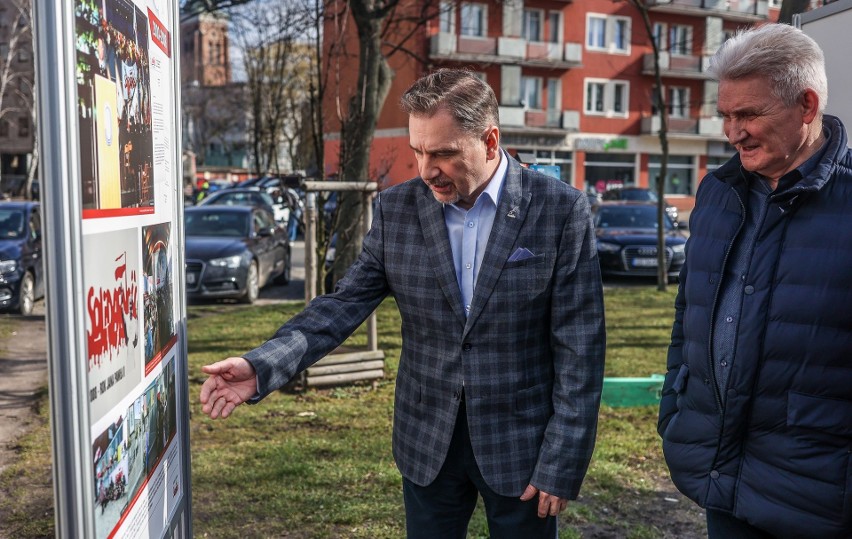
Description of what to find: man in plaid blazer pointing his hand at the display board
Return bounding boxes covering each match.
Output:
[201,70,605,538]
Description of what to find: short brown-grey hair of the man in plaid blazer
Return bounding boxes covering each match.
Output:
[400,69,500,136]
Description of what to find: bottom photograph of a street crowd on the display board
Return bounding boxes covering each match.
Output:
[92,356,177,539]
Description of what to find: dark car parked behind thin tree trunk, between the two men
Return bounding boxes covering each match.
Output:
[594,202,686,279]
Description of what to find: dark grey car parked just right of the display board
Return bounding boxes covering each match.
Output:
[184,205,290,303]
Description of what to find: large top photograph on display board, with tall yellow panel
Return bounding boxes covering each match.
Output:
[75,0,154,217]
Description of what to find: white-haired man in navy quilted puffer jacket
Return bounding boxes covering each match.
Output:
[658,24,852,539]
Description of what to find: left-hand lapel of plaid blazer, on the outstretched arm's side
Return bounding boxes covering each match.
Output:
[417,187,465,323]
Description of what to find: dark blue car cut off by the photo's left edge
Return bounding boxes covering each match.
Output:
[0,201,44,315]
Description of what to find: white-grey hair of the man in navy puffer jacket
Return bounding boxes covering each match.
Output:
[708,23,828,114]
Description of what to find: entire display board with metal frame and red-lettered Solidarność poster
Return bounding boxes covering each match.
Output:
[33,0,192,538]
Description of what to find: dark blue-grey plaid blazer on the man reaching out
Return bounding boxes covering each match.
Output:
[244,159,606,499]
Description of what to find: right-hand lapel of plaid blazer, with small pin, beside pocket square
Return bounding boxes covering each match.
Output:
[465,158,532,334]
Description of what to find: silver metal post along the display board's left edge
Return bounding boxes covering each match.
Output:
[33,1,95,537]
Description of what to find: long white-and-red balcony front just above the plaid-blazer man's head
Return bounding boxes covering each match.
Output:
[430,32,583,69]
